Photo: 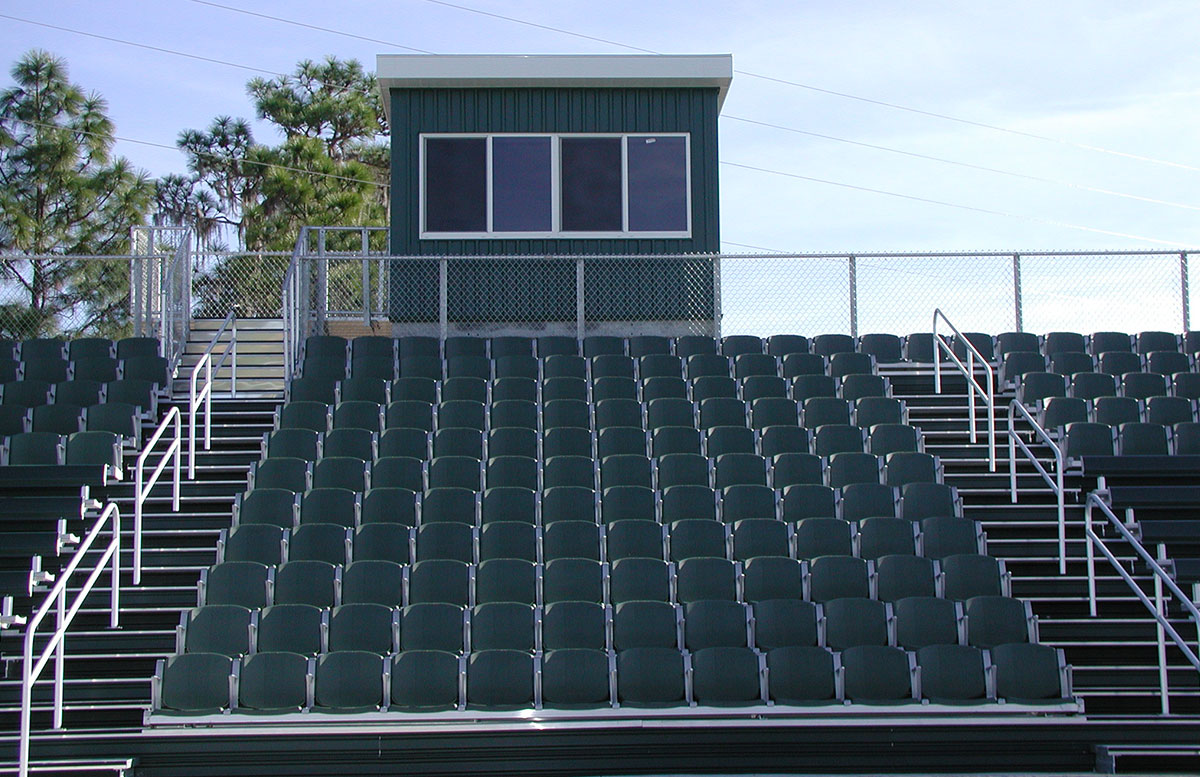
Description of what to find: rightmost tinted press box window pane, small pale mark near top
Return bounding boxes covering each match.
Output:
[628,135,688,231]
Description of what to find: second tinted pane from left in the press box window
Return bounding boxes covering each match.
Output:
[492,138,552,231]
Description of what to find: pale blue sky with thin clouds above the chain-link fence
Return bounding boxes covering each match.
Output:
[0,0,1200,252]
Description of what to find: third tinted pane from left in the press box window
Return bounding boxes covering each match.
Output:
[562,138,622,231]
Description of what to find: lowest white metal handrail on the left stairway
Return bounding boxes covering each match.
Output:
[19,502,121,777]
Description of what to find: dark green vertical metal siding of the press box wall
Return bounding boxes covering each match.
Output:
[390,88,720,321]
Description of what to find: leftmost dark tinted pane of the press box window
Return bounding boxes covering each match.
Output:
[425,138,487,233]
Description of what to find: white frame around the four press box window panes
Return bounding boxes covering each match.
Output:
[418,132,692,240]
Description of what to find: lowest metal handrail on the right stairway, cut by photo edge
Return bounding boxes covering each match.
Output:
[1084,490,1200,715]
